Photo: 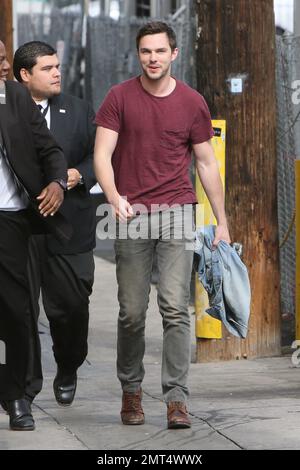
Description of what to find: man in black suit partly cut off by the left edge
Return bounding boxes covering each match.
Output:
[0,41,71,431]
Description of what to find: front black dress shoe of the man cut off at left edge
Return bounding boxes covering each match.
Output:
[5,398,35,431]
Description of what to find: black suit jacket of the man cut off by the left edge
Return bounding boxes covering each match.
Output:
[0,81,72,242]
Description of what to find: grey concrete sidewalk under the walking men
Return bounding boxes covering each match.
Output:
[0,258,300,450]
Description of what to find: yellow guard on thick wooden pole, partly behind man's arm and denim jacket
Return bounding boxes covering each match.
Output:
[195,120,226,339]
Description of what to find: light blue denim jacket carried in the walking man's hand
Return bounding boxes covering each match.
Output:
[195,225,251,338]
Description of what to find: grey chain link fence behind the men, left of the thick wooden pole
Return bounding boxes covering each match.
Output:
[17,0,196,109]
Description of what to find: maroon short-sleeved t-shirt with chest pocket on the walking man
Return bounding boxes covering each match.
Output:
[95,77,213,210]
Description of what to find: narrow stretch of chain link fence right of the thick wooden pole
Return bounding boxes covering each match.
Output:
[276,35,300,330]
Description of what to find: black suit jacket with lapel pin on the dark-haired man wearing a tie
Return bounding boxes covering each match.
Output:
[47,93,96,254]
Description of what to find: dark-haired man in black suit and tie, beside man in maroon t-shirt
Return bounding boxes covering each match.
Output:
[13,41,96,406]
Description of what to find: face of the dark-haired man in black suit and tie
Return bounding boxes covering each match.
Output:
[20,54,61,101]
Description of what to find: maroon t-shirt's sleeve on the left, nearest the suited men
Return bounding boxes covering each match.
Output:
[95,90,121,133]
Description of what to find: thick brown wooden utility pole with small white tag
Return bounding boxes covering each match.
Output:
[197,0,280,361]
